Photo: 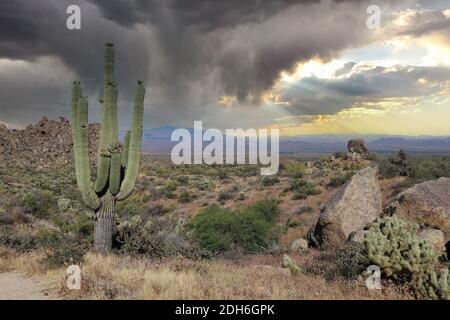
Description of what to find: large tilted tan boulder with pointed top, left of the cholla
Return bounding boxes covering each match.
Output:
[312,168,382,247]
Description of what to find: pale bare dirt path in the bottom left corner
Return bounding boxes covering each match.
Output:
[0,272,57,300]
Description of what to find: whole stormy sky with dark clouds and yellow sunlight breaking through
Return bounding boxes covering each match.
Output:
[0,0,450,135]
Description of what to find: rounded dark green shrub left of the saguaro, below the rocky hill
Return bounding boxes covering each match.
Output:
[21,189,57,219]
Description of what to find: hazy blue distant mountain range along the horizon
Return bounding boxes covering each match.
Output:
[134,125,450,154]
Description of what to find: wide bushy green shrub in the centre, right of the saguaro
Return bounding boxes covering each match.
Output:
[186,201,279,253]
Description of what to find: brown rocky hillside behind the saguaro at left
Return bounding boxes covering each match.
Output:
[0,117,100,166]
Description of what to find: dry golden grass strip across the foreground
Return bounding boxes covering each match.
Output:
[0,245,413,300]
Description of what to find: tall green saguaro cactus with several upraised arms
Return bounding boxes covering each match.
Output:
[72,43,145,252]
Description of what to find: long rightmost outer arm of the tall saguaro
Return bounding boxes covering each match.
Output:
[116,81,145,201]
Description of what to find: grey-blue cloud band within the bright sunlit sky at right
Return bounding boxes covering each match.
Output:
[280,64,450,115]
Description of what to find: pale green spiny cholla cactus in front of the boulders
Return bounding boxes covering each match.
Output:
[364,217,438,277]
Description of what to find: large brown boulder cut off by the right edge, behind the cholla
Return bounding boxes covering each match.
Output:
[385,178,450,239]
